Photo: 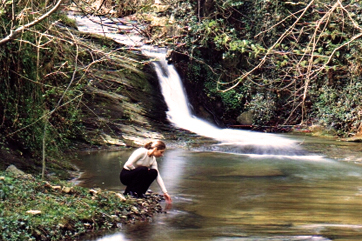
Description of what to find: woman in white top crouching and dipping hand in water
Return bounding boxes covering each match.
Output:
[120,141,172,203]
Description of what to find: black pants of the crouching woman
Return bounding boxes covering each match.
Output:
[120,166,158,197]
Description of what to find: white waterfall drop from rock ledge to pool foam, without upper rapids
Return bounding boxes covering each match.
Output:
[142,46,301,155]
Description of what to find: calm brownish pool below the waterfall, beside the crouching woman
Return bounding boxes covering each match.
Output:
[77,144,362,241]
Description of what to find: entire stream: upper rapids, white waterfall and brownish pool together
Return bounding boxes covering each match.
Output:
[67,13,362,241]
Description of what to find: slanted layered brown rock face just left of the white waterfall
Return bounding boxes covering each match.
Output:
[82,59,168,146]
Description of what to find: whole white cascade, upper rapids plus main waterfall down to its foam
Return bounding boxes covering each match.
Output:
[70,15,302,155]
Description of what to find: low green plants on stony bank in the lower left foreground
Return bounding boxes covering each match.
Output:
[0,173,160,241]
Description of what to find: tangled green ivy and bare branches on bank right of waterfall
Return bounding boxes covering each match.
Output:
[167,0,362,132]
